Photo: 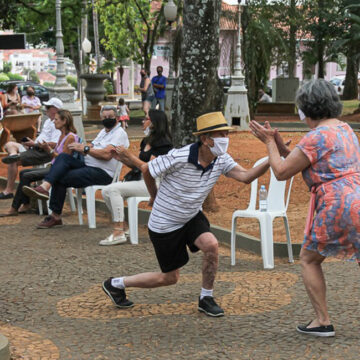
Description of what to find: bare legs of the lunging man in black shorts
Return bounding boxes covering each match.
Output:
[124,232,218,290]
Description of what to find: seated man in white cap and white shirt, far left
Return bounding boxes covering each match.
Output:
[0,98,63,200]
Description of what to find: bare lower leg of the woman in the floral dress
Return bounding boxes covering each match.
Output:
[300,249,330,328]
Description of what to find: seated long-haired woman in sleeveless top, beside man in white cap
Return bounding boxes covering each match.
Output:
[0,110,79,217]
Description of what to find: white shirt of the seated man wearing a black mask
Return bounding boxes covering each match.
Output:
[85,124,130,177]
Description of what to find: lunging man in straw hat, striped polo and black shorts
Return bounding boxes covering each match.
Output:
[103,112,269,316]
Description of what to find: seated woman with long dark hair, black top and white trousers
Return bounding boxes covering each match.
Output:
[99,110,173,245]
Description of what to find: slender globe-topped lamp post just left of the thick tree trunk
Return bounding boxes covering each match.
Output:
[164,0,177,121]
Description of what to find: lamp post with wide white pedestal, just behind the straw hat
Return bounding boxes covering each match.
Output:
[225,0,250,130]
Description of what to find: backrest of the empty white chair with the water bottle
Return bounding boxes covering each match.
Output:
[247,157,294,211]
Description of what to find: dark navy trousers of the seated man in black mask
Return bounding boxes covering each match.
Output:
[44,153,112,214]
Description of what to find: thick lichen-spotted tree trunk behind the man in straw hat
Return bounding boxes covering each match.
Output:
[171,0,224,211]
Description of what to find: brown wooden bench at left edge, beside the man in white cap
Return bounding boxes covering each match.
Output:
[0,112,41,151]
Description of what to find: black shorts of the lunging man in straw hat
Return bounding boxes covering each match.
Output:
[149,211,211,273]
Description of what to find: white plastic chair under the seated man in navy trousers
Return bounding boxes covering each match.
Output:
[76,161,122,229]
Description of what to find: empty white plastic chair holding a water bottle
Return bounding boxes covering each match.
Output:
[231,157,294,269]
